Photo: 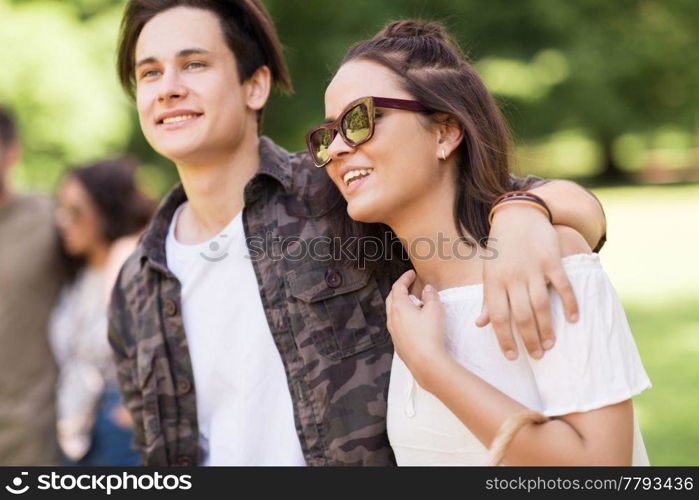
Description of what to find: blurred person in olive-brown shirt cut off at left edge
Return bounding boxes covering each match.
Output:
[0,106,63,466]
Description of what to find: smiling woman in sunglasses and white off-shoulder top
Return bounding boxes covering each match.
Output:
[307,21,650,465]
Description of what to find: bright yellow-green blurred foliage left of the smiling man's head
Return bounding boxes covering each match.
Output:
[0,1,131,188]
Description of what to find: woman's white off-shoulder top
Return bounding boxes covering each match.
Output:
[387,254,650,465]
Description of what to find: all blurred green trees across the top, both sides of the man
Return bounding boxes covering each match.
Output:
[0,0,699,194]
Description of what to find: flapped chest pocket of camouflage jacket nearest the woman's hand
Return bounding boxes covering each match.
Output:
[286,261,389,360]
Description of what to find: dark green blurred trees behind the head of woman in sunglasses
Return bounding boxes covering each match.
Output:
[266,0,699,177]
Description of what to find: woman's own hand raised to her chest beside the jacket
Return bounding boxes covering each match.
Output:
[386,270,447,385]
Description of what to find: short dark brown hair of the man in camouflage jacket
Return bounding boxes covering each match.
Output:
[117,0,292,97]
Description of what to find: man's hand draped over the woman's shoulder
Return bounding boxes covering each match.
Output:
[476,204,578,359]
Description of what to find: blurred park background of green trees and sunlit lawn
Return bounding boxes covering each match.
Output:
[0,0,699,465]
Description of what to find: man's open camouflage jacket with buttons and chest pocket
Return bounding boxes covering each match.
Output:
[109,138,395,465]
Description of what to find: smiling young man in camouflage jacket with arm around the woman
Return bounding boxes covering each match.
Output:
[109,0,604,465]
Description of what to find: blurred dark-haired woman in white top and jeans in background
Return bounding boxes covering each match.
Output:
[49,159,154,466]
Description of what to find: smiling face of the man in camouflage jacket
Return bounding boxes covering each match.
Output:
[135,7,256,163]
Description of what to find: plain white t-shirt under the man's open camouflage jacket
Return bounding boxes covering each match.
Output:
[165,203,306,465]
